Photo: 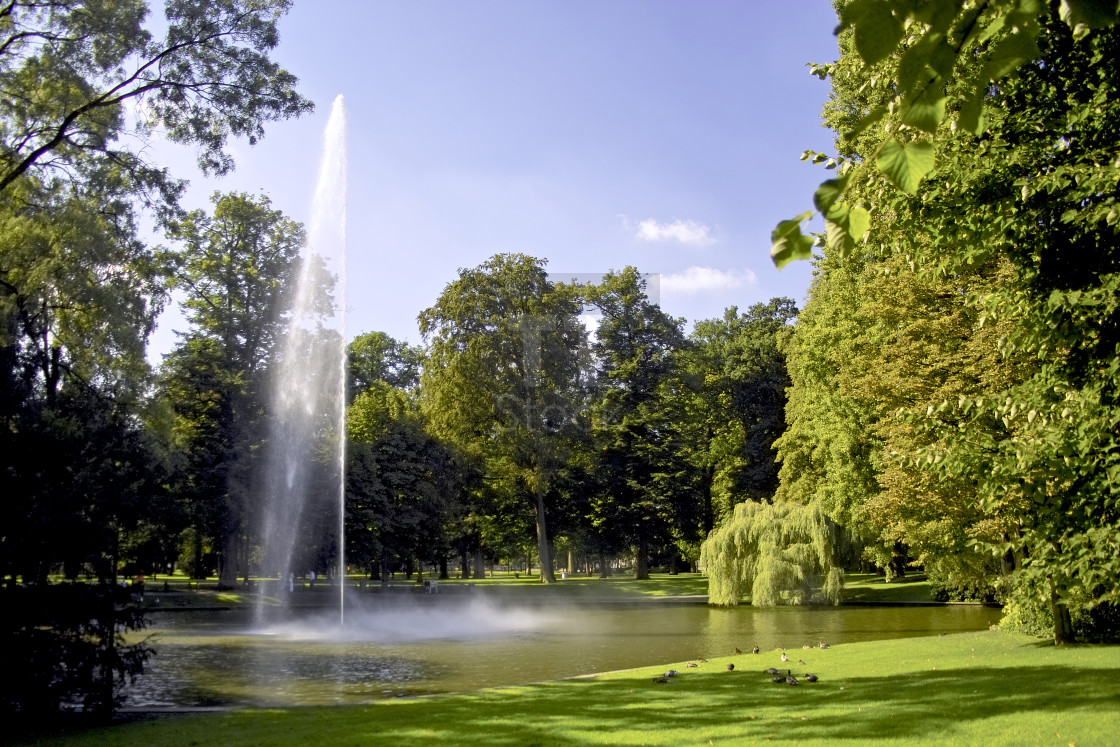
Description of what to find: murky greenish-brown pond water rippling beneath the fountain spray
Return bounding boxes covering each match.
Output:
[125,597,1000,709]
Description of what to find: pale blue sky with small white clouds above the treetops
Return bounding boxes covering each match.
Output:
[151,0,837,354]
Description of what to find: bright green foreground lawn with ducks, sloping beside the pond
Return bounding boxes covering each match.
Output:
[26,632,1120,747]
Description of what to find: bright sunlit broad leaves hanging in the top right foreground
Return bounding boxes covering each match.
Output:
[771,0,1120,268]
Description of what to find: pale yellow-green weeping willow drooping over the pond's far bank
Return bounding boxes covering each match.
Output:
[700,501,843,607]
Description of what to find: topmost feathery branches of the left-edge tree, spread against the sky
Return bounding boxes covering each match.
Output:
[0,0,311,198]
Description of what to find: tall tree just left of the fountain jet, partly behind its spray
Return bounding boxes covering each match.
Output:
[165,188,311,580]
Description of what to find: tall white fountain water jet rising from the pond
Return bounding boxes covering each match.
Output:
[258,95,346,622]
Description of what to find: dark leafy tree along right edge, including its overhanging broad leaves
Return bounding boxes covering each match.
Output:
[774,2,1120,642]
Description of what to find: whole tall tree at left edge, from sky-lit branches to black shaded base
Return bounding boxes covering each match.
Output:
[0,0,310,710]
